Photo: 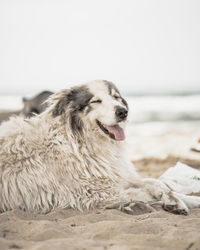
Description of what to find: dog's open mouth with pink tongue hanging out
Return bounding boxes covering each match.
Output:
[97,120,125,141]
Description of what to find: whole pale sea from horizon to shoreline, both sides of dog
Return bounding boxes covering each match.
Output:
[0,95,200,134]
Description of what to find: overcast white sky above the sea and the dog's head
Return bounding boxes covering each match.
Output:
[0,0,200,94]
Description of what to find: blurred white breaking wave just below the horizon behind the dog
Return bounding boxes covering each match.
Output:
[0,95,200,124]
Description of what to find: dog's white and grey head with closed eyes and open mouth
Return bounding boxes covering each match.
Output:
[53,81,128,141]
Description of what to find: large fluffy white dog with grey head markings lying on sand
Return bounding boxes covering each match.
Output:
[0,81,200,214]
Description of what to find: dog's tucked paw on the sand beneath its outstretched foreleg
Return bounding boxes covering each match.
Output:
[105,201,156,215]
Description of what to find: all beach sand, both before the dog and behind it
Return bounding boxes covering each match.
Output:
[0,114,200,250]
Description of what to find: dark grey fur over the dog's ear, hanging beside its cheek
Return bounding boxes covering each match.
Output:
[53,86,93,135]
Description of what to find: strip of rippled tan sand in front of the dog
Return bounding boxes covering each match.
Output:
[0,209,200,250]
